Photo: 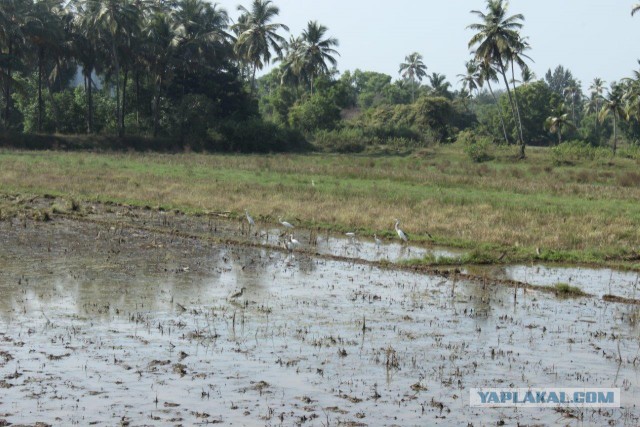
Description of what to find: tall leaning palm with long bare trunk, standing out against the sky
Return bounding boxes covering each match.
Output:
[467,0,526,158]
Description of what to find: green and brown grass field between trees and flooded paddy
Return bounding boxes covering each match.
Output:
[0,145,640,268]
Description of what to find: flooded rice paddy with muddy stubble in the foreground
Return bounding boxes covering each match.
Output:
[0,199,640,426]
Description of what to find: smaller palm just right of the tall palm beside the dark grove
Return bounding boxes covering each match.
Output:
[300,21,340,95]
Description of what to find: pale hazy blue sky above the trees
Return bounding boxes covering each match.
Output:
[212,0,640,90]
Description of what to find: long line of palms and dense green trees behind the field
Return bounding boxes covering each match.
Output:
[0,0,640,157]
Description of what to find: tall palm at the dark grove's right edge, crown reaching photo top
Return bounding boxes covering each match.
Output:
[234,0,289,94]
